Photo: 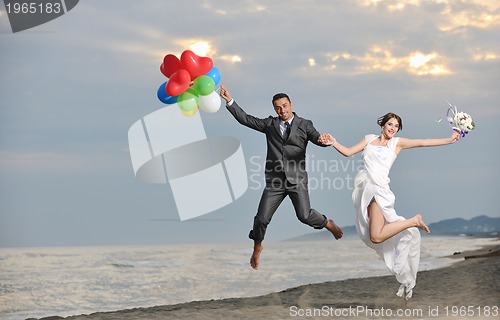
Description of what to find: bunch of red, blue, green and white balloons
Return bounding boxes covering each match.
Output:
[157,50,221,116]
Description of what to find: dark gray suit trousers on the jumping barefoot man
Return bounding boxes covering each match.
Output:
[248,179,328,243]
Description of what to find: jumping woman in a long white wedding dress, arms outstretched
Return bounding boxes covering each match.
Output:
[322,113,460,300]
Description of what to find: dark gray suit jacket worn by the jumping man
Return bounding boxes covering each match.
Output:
[227,101,323,185]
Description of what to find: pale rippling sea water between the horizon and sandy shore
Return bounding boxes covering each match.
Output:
[0,236,499,320]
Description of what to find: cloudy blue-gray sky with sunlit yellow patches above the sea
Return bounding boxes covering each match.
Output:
[0,0,500,247]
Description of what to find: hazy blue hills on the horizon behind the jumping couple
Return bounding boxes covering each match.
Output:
[285,216,500,241]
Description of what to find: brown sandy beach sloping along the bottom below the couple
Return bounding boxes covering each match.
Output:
[29,242,500,320]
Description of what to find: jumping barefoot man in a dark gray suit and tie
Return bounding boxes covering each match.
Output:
[220,86,343,269]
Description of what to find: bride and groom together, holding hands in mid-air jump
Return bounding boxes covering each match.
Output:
[220,86,460,299]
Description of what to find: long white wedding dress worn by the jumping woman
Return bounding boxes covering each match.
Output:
[352,134,420,300]
